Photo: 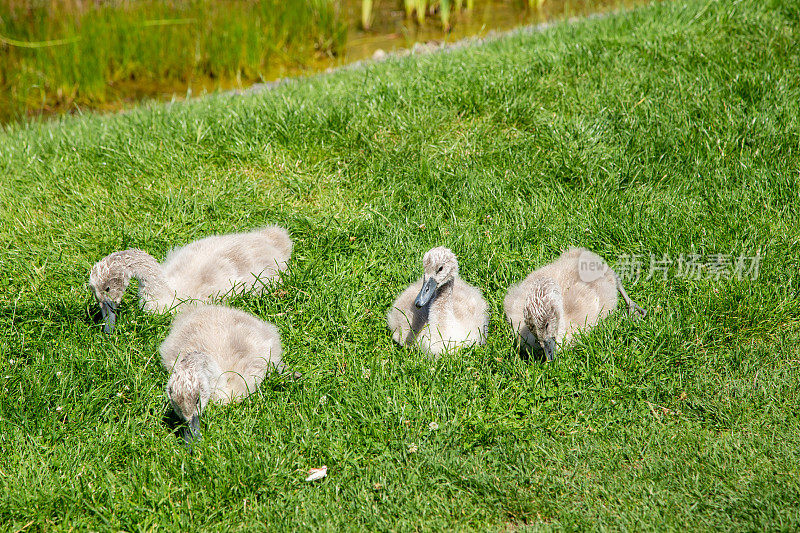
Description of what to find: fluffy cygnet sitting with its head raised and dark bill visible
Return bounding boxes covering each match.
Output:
[387,247,489,356]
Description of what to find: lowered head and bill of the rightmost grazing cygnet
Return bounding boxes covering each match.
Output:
[522,278,564,361]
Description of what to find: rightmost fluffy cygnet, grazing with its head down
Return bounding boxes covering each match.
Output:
[504,248,646,361]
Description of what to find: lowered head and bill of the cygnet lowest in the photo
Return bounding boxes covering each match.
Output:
[167,351,212,444]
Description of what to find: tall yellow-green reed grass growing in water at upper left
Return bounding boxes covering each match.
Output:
[0,0,347,119]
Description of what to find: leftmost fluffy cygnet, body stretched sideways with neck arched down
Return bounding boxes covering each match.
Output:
[89,226,292,333]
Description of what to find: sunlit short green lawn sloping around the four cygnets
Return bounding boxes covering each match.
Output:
[0,0,800,531]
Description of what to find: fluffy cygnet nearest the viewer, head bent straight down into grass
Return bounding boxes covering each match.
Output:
[160,305,290,442]
